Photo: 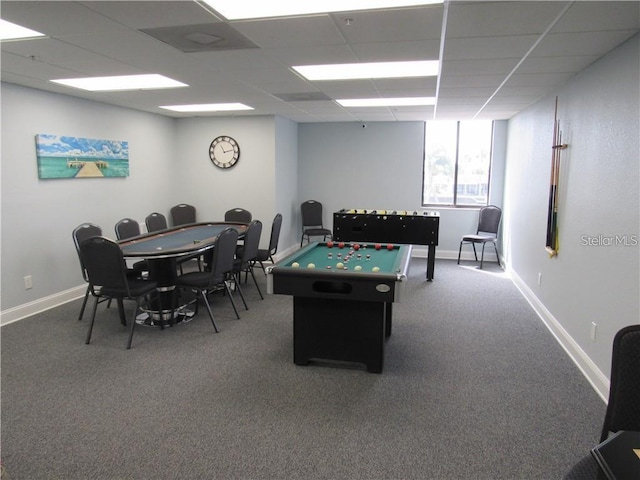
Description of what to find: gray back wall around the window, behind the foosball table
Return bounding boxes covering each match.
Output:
[298,122,506,259]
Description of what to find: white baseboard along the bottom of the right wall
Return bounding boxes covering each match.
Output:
[510,271,610,403]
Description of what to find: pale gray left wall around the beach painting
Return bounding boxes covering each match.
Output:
[1,83,178,311]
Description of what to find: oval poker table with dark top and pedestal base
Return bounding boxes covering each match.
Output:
[118,222,247,324]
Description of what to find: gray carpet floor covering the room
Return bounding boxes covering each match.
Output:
[1,259,605,480]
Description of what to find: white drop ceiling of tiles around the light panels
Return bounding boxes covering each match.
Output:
[0,0,640,122]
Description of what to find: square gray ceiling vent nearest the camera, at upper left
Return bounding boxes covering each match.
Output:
[140,23,258,53]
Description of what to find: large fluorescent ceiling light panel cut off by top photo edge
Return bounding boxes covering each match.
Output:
[204,0,443,20]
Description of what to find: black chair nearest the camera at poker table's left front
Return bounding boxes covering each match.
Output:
[80,237,158,348]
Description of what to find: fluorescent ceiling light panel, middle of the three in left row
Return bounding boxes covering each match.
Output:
[51,74,188,92]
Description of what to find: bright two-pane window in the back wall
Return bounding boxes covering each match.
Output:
[422,121,493,206]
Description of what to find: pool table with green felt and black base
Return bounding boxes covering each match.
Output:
[267,242,412,373]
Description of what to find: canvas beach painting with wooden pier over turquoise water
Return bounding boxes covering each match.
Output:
[36,133,129,178]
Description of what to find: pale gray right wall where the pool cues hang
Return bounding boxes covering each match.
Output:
[504,36,640,382]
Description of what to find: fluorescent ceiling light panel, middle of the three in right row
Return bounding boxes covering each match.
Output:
[292,60,438,81]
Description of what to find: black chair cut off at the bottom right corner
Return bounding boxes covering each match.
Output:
[564,325,640,480]
